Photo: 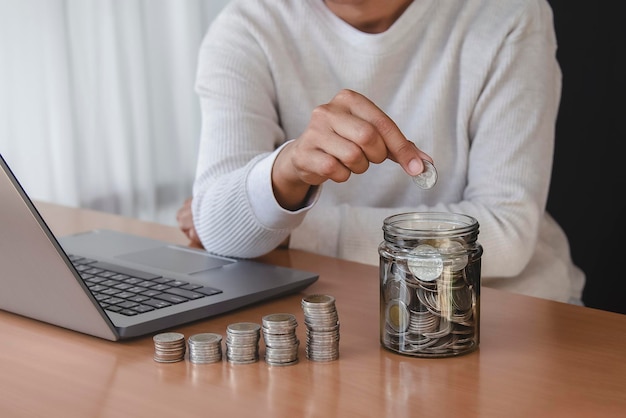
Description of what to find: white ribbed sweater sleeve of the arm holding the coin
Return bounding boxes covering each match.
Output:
[192,8,308,258]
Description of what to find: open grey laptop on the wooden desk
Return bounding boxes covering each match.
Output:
[0,155,319,341]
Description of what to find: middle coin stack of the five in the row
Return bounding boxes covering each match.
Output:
[226,322,261,364]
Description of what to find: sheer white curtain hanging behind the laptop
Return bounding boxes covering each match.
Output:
[0,0,228,224]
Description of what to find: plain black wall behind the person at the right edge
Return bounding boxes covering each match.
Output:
[548,0,626,314]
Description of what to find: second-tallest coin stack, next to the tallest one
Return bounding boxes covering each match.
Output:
[263,313,300,366]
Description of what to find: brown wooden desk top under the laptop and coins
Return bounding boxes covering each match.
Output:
[0,204,626,418]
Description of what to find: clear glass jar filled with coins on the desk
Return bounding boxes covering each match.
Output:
[378,212,483,357]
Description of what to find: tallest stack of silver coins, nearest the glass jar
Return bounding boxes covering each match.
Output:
[302,295,339,361]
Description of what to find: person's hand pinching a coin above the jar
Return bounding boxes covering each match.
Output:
[272,90,433,210]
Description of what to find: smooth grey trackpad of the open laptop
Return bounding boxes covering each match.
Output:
[117,246,234,274]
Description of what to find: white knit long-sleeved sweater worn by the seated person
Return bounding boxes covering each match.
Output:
[193,0,584,301]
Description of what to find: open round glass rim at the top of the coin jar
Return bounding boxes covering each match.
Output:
[383,212,478,237]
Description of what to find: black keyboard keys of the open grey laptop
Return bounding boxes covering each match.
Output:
[69,255,222,316]
